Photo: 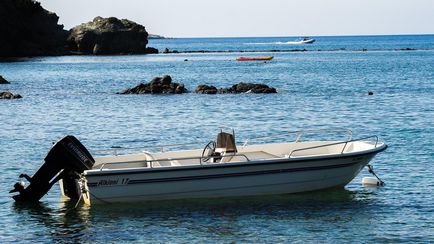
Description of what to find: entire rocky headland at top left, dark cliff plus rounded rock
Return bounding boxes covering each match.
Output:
[0,0,158,58]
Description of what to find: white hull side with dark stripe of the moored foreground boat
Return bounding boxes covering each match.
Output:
[84,149,384,204]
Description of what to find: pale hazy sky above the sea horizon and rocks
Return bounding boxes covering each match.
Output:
[39,0,434,37]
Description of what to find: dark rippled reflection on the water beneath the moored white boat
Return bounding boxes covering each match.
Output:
[13,188,375,242]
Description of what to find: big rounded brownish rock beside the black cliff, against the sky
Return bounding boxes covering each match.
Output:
[68,16,148,54]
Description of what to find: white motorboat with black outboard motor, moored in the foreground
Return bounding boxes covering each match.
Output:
[11,130,387,204]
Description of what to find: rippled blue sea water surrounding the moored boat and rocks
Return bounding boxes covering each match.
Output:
[0,35,434,243]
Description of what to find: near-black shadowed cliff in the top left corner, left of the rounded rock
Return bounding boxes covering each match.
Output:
[0,0,68,57]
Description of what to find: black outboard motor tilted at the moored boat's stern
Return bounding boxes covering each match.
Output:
[9,136,95,202]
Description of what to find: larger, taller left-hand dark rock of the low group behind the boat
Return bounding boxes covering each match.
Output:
[118,75,188,94]
